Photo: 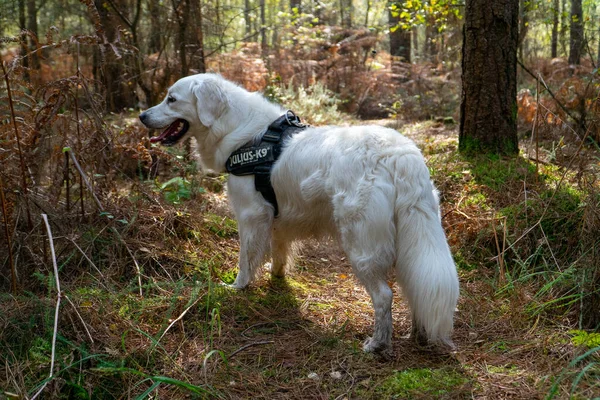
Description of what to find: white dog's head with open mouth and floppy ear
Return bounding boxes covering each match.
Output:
[140,74,228,146]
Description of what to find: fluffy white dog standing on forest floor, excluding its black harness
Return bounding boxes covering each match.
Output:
[140,74,459,352]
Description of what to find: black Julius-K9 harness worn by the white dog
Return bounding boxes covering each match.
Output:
[225,110,308,217]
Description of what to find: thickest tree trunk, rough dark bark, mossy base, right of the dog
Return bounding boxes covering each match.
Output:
[459,0,519,155]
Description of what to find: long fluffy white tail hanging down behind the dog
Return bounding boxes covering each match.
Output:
[395,155,459,348]
